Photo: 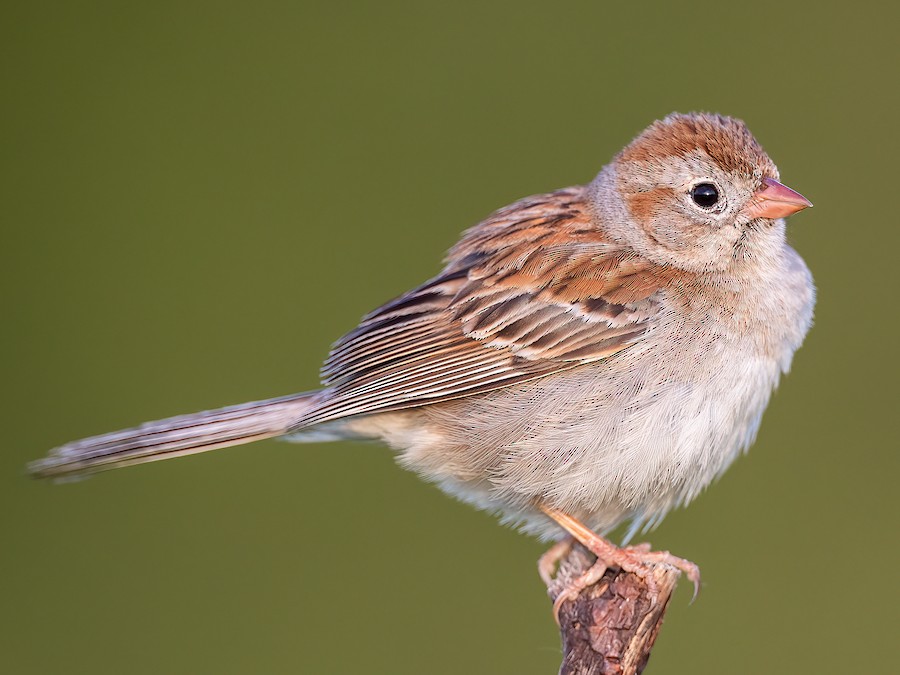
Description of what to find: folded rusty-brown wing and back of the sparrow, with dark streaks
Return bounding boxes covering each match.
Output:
[302,187,671,424]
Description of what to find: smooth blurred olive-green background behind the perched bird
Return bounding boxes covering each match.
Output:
[0,1,900,675]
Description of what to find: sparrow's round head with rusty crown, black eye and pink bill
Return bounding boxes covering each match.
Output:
[591,113,811,272]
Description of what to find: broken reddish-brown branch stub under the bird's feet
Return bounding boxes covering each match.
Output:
[548,544,680,675]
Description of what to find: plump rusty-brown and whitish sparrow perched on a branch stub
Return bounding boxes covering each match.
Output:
[29,113,815,611]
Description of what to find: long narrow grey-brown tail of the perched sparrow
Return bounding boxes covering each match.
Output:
[28,392,318,478]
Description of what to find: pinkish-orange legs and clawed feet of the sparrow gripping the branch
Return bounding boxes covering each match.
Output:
[539,507,700,622]
